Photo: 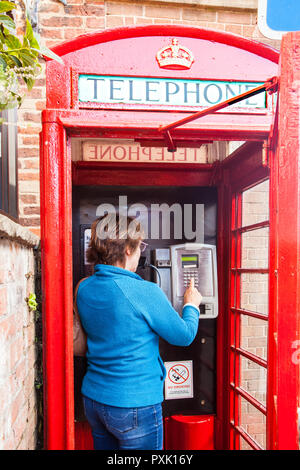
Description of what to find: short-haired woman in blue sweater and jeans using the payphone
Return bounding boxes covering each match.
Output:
[77,214,202,450]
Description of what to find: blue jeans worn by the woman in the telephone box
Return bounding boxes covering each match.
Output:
[83,397,163,450]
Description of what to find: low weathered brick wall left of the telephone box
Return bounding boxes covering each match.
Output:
[0,215,38,450]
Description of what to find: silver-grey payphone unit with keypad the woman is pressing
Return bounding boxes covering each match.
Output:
[170,243,218,319]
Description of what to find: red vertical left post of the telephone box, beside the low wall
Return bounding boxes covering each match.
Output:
[41,123,74,449]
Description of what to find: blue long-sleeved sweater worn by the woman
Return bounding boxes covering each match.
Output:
[77,264,199,407]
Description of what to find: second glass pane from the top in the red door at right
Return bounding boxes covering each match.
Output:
[242,227,269,269]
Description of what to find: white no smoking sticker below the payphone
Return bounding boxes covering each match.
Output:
[165,361,194,400]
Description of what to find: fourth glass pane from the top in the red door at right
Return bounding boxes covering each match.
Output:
[240,315,268,360]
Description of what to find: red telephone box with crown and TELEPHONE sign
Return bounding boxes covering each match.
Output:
[41,25,300,449]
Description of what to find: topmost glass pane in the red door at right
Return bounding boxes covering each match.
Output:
[242,180,269,226]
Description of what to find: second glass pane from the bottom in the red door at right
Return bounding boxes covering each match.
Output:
[240,356,267,406]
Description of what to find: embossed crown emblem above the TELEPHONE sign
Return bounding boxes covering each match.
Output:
[156,39,194,70]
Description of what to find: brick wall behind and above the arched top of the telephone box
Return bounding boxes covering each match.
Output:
[18,0,279,235]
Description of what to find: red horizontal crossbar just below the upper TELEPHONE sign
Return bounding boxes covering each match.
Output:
[43,110,272,141]
